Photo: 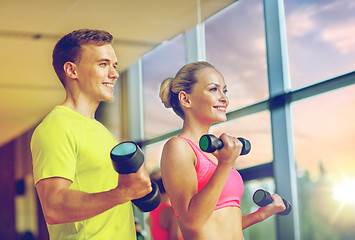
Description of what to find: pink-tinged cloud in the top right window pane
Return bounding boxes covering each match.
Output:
[286,0,355,54]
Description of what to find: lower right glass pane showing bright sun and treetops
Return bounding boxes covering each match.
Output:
[292,85,355,239]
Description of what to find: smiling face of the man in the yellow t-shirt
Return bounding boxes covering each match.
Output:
[75,44,119,103]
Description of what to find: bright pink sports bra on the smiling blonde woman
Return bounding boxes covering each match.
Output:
[179,136,244,210]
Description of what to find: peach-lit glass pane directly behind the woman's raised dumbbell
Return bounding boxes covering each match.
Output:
[211,111,273,169]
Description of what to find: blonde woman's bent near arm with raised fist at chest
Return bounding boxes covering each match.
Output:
[161,135,241,230]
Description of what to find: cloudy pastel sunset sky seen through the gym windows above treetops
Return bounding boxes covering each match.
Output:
[143,0,355,184]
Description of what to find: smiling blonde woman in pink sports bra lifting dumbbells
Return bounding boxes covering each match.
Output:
[160,62,285,240]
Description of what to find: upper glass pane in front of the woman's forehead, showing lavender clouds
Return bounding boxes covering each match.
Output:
[205,0,268,110]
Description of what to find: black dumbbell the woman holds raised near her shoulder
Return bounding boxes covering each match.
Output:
[199,134,251,155]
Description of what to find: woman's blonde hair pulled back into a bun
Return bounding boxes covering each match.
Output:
[159,61,216,119]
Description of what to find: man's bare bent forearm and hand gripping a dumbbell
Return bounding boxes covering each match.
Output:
[36,164,152,224]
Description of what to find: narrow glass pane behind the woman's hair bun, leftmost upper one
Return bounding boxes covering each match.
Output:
[142,34,185,138]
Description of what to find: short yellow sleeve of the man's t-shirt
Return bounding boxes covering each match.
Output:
[31,118,77,184]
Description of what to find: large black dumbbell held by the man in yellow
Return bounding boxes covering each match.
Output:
[110,141,160,212]
